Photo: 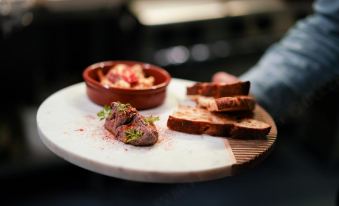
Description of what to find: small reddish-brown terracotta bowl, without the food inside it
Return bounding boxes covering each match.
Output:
[82,61,171,110]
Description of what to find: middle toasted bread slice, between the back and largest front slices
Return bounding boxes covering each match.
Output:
[194,96,255,112]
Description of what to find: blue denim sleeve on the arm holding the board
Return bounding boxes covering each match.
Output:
[240,0,339,120]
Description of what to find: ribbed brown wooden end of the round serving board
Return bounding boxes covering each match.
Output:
[228,105,277,174]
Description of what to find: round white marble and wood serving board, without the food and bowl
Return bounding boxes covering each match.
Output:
[37,79,277,182]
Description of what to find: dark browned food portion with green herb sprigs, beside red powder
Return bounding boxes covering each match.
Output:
[105,102,159,146]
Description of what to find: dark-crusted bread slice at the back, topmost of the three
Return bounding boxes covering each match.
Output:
[187,81,250,98]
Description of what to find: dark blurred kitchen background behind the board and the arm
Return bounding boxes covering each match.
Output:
[0,0,339,206]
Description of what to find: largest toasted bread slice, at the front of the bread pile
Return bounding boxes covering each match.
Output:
[167,106,271,138]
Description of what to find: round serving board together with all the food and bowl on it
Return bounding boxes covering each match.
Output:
[37,61,277,182]
